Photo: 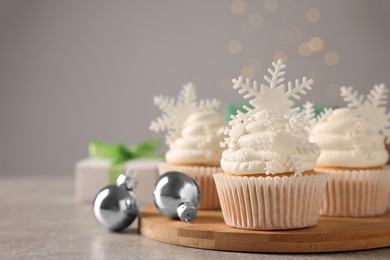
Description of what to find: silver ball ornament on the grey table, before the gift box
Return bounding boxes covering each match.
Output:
[93,174,139,231]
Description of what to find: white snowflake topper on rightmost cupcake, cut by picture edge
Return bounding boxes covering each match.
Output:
[341,83,390,143]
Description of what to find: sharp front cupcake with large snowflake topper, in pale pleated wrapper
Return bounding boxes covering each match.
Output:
[214,60,327,230]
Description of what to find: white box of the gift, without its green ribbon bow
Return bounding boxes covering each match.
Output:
[74,158,161,206]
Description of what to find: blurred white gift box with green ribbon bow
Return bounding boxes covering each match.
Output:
[74,138,163,206]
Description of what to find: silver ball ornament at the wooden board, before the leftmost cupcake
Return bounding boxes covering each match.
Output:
[153,171,201,222]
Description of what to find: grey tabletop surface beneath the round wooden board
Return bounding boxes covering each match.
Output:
[0,177,390,259]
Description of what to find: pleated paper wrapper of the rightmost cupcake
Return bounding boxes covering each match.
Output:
[321,166,390,217]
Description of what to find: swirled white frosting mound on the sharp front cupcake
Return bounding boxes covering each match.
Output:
[221,111,320,175]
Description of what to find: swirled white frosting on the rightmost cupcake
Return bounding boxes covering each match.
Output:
[310,108,388,168]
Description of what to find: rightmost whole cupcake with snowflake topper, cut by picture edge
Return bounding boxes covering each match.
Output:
[310,84,390,217]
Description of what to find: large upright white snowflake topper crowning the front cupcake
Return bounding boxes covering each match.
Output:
[232,59,313,124]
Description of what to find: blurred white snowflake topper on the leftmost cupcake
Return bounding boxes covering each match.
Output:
[149,82,220,144]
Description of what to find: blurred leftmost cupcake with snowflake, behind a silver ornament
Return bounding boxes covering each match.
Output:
[150,83,227,210]
